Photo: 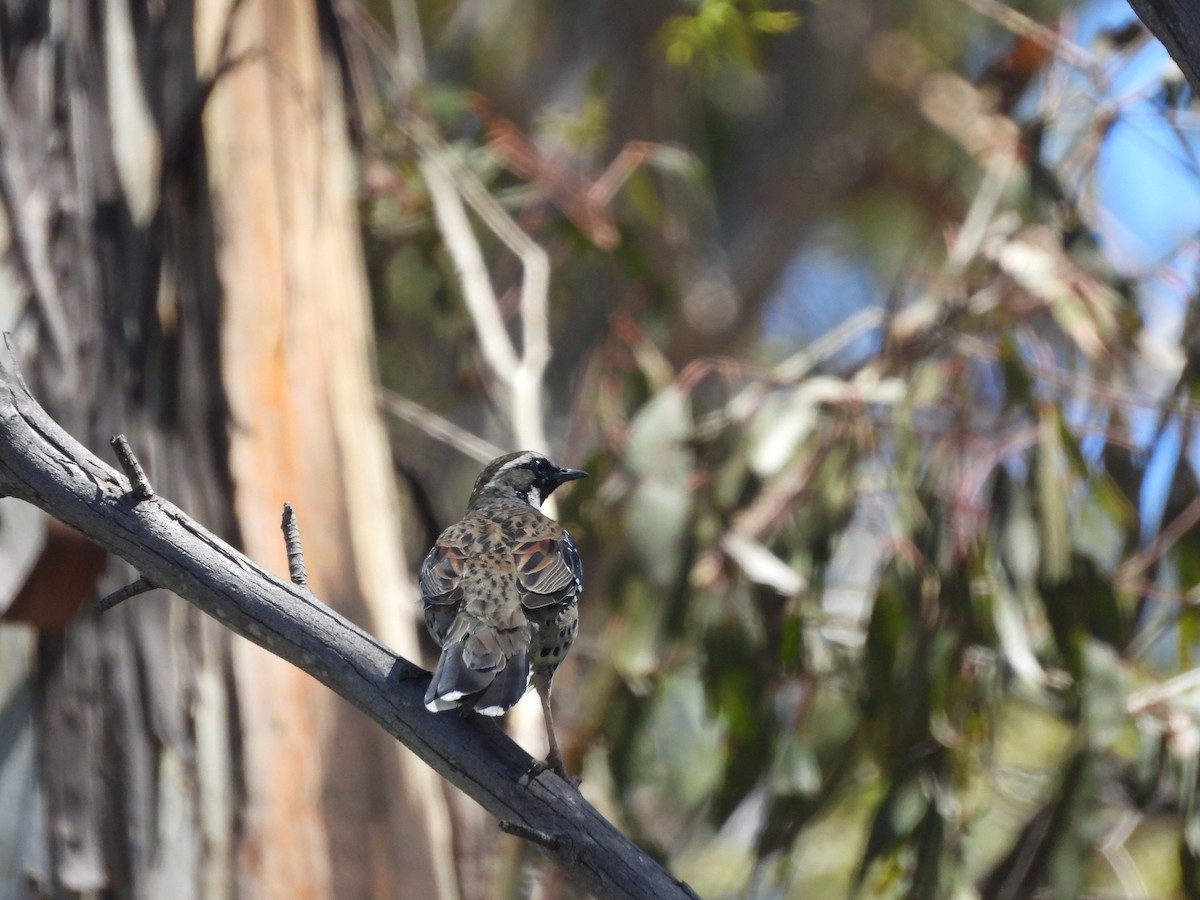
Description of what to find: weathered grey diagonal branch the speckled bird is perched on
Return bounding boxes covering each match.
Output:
[0,336,694,900]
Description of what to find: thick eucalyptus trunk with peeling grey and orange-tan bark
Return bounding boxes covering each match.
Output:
[0,0,457,900]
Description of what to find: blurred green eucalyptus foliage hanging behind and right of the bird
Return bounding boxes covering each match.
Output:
[343,0,1200,898]
